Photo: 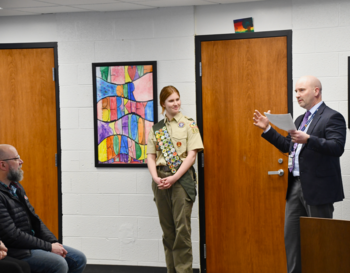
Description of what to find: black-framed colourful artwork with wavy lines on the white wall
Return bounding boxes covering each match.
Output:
[92,61,158,167]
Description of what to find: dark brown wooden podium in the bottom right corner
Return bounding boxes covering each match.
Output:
[300,217,350,273]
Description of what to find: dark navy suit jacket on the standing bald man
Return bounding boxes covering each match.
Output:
[262,103,346,206]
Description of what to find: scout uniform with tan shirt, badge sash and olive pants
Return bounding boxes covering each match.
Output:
[147,113,204,273]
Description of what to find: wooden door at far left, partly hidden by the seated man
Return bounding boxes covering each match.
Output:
[0,48,59,238]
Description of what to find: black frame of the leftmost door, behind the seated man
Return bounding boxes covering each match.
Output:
[0,42,62,243]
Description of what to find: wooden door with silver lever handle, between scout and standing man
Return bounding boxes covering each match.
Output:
[201,37,288,273]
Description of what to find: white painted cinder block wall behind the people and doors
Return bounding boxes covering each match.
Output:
[0,0,350,267]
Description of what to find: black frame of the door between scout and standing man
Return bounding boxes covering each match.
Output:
[195,30,293,273]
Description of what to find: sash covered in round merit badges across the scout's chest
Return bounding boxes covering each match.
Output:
[154,125,182,174]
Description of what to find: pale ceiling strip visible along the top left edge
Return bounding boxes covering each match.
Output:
[0,0,263,16]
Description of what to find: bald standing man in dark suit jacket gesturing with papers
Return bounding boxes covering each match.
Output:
[253,76,346,273]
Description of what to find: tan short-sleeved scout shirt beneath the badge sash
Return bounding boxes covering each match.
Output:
[147,112,204,166]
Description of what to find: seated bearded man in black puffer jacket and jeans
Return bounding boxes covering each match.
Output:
[0,144,86,273]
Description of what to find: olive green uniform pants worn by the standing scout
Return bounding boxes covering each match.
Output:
[152,170,193,273]
